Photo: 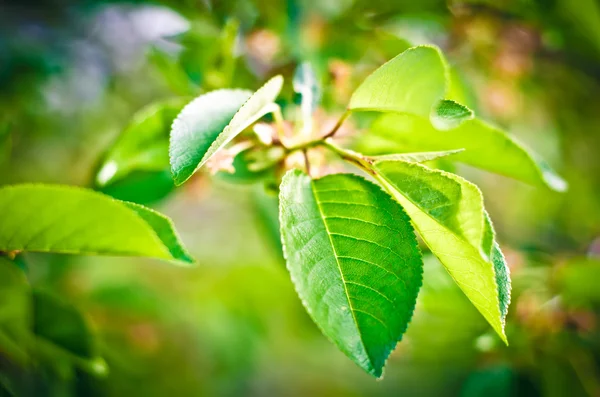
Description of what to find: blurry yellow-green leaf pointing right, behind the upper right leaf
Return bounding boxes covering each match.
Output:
[359,114,567,191]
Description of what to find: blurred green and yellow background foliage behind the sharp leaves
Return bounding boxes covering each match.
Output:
[0,0,600,397]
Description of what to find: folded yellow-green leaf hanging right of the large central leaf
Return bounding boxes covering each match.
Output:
[374,161,510,342]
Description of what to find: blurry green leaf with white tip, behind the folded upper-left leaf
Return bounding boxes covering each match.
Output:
[96,98,185,186]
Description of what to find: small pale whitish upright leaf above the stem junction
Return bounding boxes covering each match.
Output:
[292,62,321,134]
